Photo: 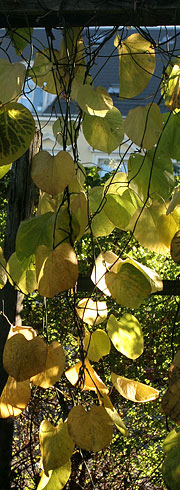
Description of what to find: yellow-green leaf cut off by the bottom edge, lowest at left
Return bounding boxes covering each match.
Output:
[37,461,71,490]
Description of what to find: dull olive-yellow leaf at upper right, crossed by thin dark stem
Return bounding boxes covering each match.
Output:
[124,103,162,150]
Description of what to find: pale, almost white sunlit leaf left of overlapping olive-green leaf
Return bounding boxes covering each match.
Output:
[91,250,122,296]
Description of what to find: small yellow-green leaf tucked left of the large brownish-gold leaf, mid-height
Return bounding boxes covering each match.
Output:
[7,252,37,294]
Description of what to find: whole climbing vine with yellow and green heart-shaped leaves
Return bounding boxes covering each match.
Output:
[0,23,180,490]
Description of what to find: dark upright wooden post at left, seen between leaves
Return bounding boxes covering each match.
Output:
[0,133,41,490]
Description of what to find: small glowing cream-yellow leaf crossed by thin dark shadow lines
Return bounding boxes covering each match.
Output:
[76,298,107,325]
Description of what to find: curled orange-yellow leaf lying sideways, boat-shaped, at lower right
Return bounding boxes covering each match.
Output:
[111,373,159,403]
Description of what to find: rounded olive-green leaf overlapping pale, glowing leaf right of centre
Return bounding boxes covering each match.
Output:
[105,261,151,308]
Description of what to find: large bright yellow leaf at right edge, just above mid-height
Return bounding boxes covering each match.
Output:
[130,201,179,254]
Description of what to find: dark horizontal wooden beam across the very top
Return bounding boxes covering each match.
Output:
[0,0,180,28]
